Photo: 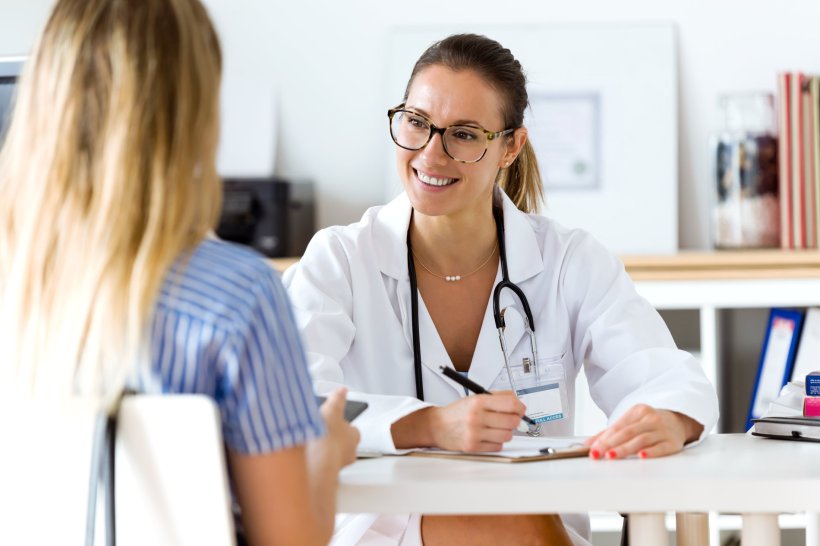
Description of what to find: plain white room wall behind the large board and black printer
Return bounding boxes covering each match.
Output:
[0,0,820,248]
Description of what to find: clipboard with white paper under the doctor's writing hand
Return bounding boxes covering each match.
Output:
[407,436,589,463]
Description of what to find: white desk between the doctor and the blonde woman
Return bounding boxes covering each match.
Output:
[338,434,820,546]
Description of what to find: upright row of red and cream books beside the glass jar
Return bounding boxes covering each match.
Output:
[777,72,820,249]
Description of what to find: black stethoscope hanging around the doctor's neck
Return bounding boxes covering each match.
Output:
[407,206,538,400]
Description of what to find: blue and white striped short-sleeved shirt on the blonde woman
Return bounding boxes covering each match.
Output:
[138,239,324,454]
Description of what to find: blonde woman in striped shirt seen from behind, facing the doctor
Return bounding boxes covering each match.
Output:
[0,0,358,544]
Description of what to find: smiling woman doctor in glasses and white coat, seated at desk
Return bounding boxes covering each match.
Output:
[285,35,717,546]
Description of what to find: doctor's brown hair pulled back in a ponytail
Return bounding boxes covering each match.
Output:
[404,34,544,212]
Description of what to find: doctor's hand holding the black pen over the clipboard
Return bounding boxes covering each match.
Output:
[429,391,527,451]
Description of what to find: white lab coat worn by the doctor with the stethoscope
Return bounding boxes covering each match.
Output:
[284,189,718,544]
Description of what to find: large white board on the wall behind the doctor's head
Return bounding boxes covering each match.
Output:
[385,23,678,254]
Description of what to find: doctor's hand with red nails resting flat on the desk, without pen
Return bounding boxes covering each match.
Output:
[585,404,703,459]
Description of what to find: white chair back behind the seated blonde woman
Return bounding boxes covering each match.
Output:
[0,395,235,546]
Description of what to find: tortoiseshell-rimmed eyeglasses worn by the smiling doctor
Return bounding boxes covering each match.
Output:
[387,104,515,163]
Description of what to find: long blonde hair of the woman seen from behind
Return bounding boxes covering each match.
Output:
[0,0,222,397]
